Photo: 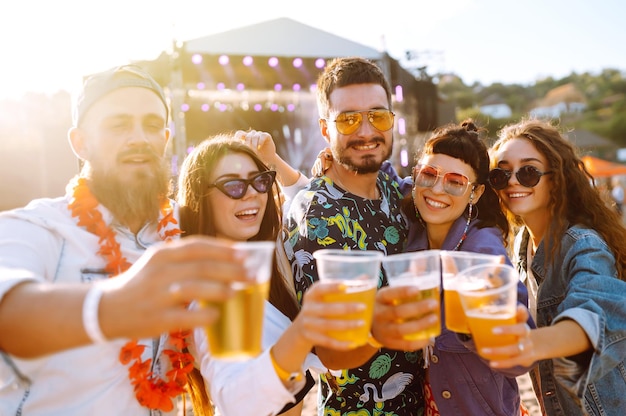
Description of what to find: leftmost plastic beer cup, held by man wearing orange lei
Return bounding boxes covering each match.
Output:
[206,241,275,360]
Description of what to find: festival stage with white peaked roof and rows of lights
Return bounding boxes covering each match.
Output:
[142,18,437,174]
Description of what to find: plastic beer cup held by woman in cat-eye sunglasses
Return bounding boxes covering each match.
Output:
[313,249,384,347]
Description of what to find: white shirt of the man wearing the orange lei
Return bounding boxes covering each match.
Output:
[0,197,173,416]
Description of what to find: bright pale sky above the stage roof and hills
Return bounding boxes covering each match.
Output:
[0,0,626,99]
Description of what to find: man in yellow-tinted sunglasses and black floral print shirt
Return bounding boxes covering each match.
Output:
[284,58,424,416]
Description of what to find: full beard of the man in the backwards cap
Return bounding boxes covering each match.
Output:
[86,158,170,226]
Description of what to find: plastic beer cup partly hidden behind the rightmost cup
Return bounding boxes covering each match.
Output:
[440,250,504,334]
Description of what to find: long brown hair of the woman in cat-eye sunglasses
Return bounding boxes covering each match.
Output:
[176,133,299,416]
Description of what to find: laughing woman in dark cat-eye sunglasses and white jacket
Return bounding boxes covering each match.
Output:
[177,132,366,416]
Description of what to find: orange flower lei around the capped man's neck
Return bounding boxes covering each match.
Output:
[69,178,194,412]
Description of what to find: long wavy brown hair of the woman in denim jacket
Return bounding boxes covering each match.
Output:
[492,119,626,280]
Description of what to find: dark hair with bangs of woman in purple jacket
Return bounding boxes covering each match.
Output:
[402,119,509,245]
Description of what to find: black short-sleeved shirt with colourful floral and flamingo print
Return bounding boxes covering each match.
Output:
[284,172,424,416]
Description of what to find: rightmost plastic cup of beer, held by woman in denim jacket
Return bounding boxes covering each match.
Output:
[458,264,519,360]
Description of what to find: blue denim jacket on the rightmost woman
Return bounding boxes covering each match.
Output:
[515,225,626,416]
